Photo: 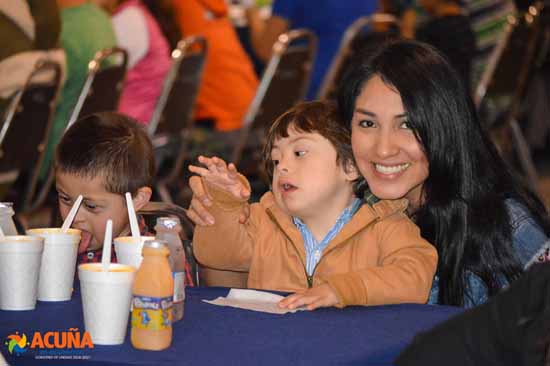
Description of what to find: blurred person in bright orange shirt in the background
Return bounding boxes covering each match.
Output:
[173,0,258,132]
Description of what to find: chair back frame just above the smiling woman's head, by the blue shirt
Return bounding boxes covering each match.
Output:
[317,13,399,99]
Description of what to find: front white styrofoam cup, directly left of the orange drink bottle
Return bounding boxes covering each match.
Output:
[78,263,136,345]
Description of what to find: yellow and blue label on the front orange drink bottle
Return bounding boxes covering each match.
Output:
[132,295,172,330]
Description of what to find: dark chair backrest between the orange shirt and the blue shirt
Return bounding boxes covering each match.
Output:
[232,29,317,164]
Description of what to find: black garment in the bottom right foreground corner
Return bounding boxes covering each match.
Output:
[395,263,550,366]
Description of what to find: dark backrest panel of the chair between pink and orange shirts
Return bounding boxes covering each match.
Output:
[147,36,207,136]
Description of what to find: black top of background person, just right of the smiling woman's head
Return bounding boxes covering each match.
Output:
[416,15,477,91]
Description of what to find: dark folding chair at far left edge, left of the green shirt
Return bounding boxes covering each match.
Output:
[0,60,61,211]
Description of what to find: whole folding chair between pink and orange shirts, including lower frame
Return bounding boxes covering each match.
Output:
[148,36,207,202]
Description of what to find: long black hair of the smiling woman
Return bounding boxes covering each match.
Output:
[338,40,550,305]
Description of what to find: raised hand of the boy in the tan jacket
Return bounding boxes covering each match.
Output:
[189,156,250,199]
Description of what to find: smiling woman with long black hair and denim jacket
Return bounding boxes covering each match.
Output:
[338,40,550,307]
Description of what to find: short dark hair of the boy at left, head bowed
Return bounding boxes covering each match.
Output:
[54,112,155,195]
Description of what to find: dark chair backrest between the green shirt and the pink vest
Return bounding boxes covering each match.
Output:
[66,47,128,129]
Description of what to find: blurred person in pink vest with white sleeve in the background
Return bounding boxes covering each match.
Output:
[95,0,171,125]
